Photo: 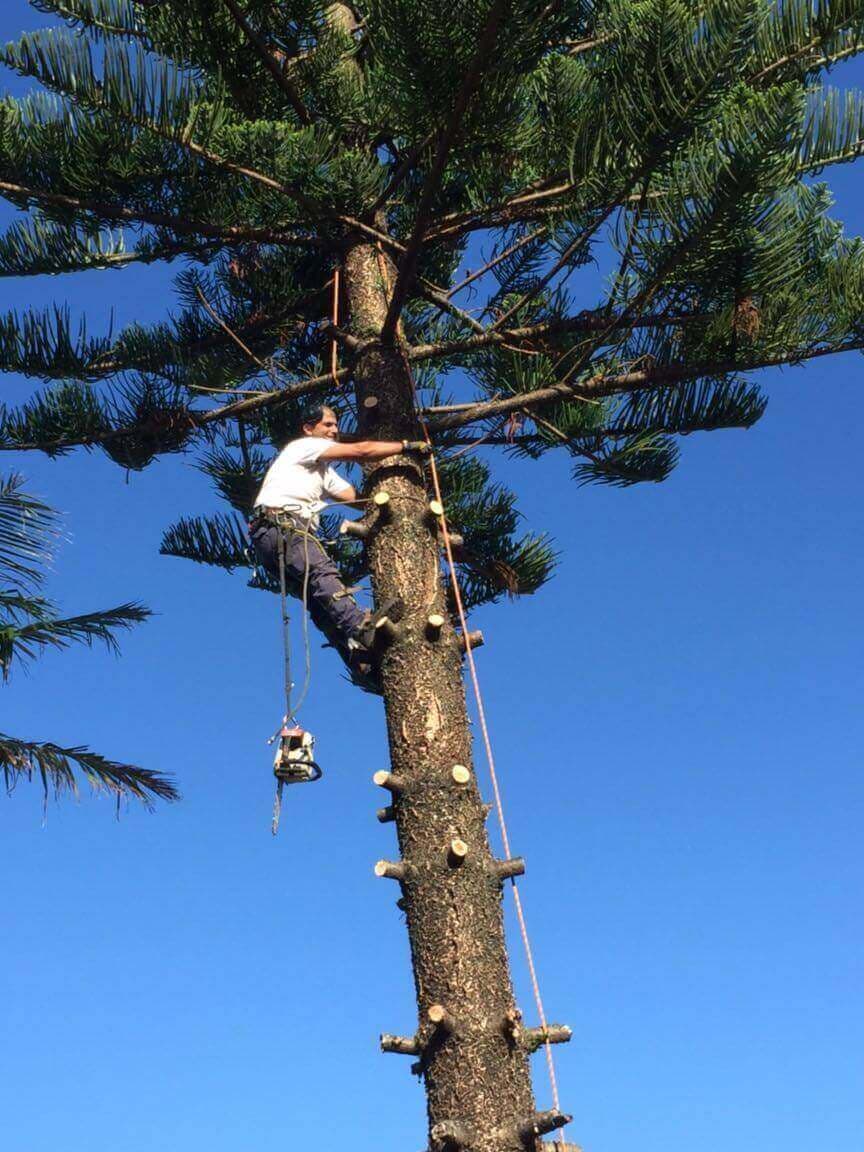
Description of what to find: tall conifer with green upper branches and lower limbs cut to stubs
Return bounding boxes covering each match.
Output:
[0,0,864,1152]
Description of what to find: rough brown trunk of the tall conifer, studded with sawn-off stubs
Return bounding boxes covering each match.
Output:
[344,241,550,1152]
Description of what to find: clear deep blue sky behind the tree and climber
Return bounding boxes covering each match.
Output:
[0,0,864,1152]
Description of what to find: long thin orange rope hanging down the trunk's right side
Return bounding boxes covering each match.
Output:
[377,244,566,1152]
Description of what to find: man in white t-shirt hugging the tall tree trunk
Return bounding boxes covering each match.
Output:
[249,404,430,669]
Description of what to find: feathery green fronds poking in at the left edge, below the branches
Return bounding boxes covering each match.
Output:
[0,475,177,808]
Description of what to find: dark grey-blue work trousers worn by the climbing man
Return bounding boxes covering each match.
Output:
[251,517,365,649]
